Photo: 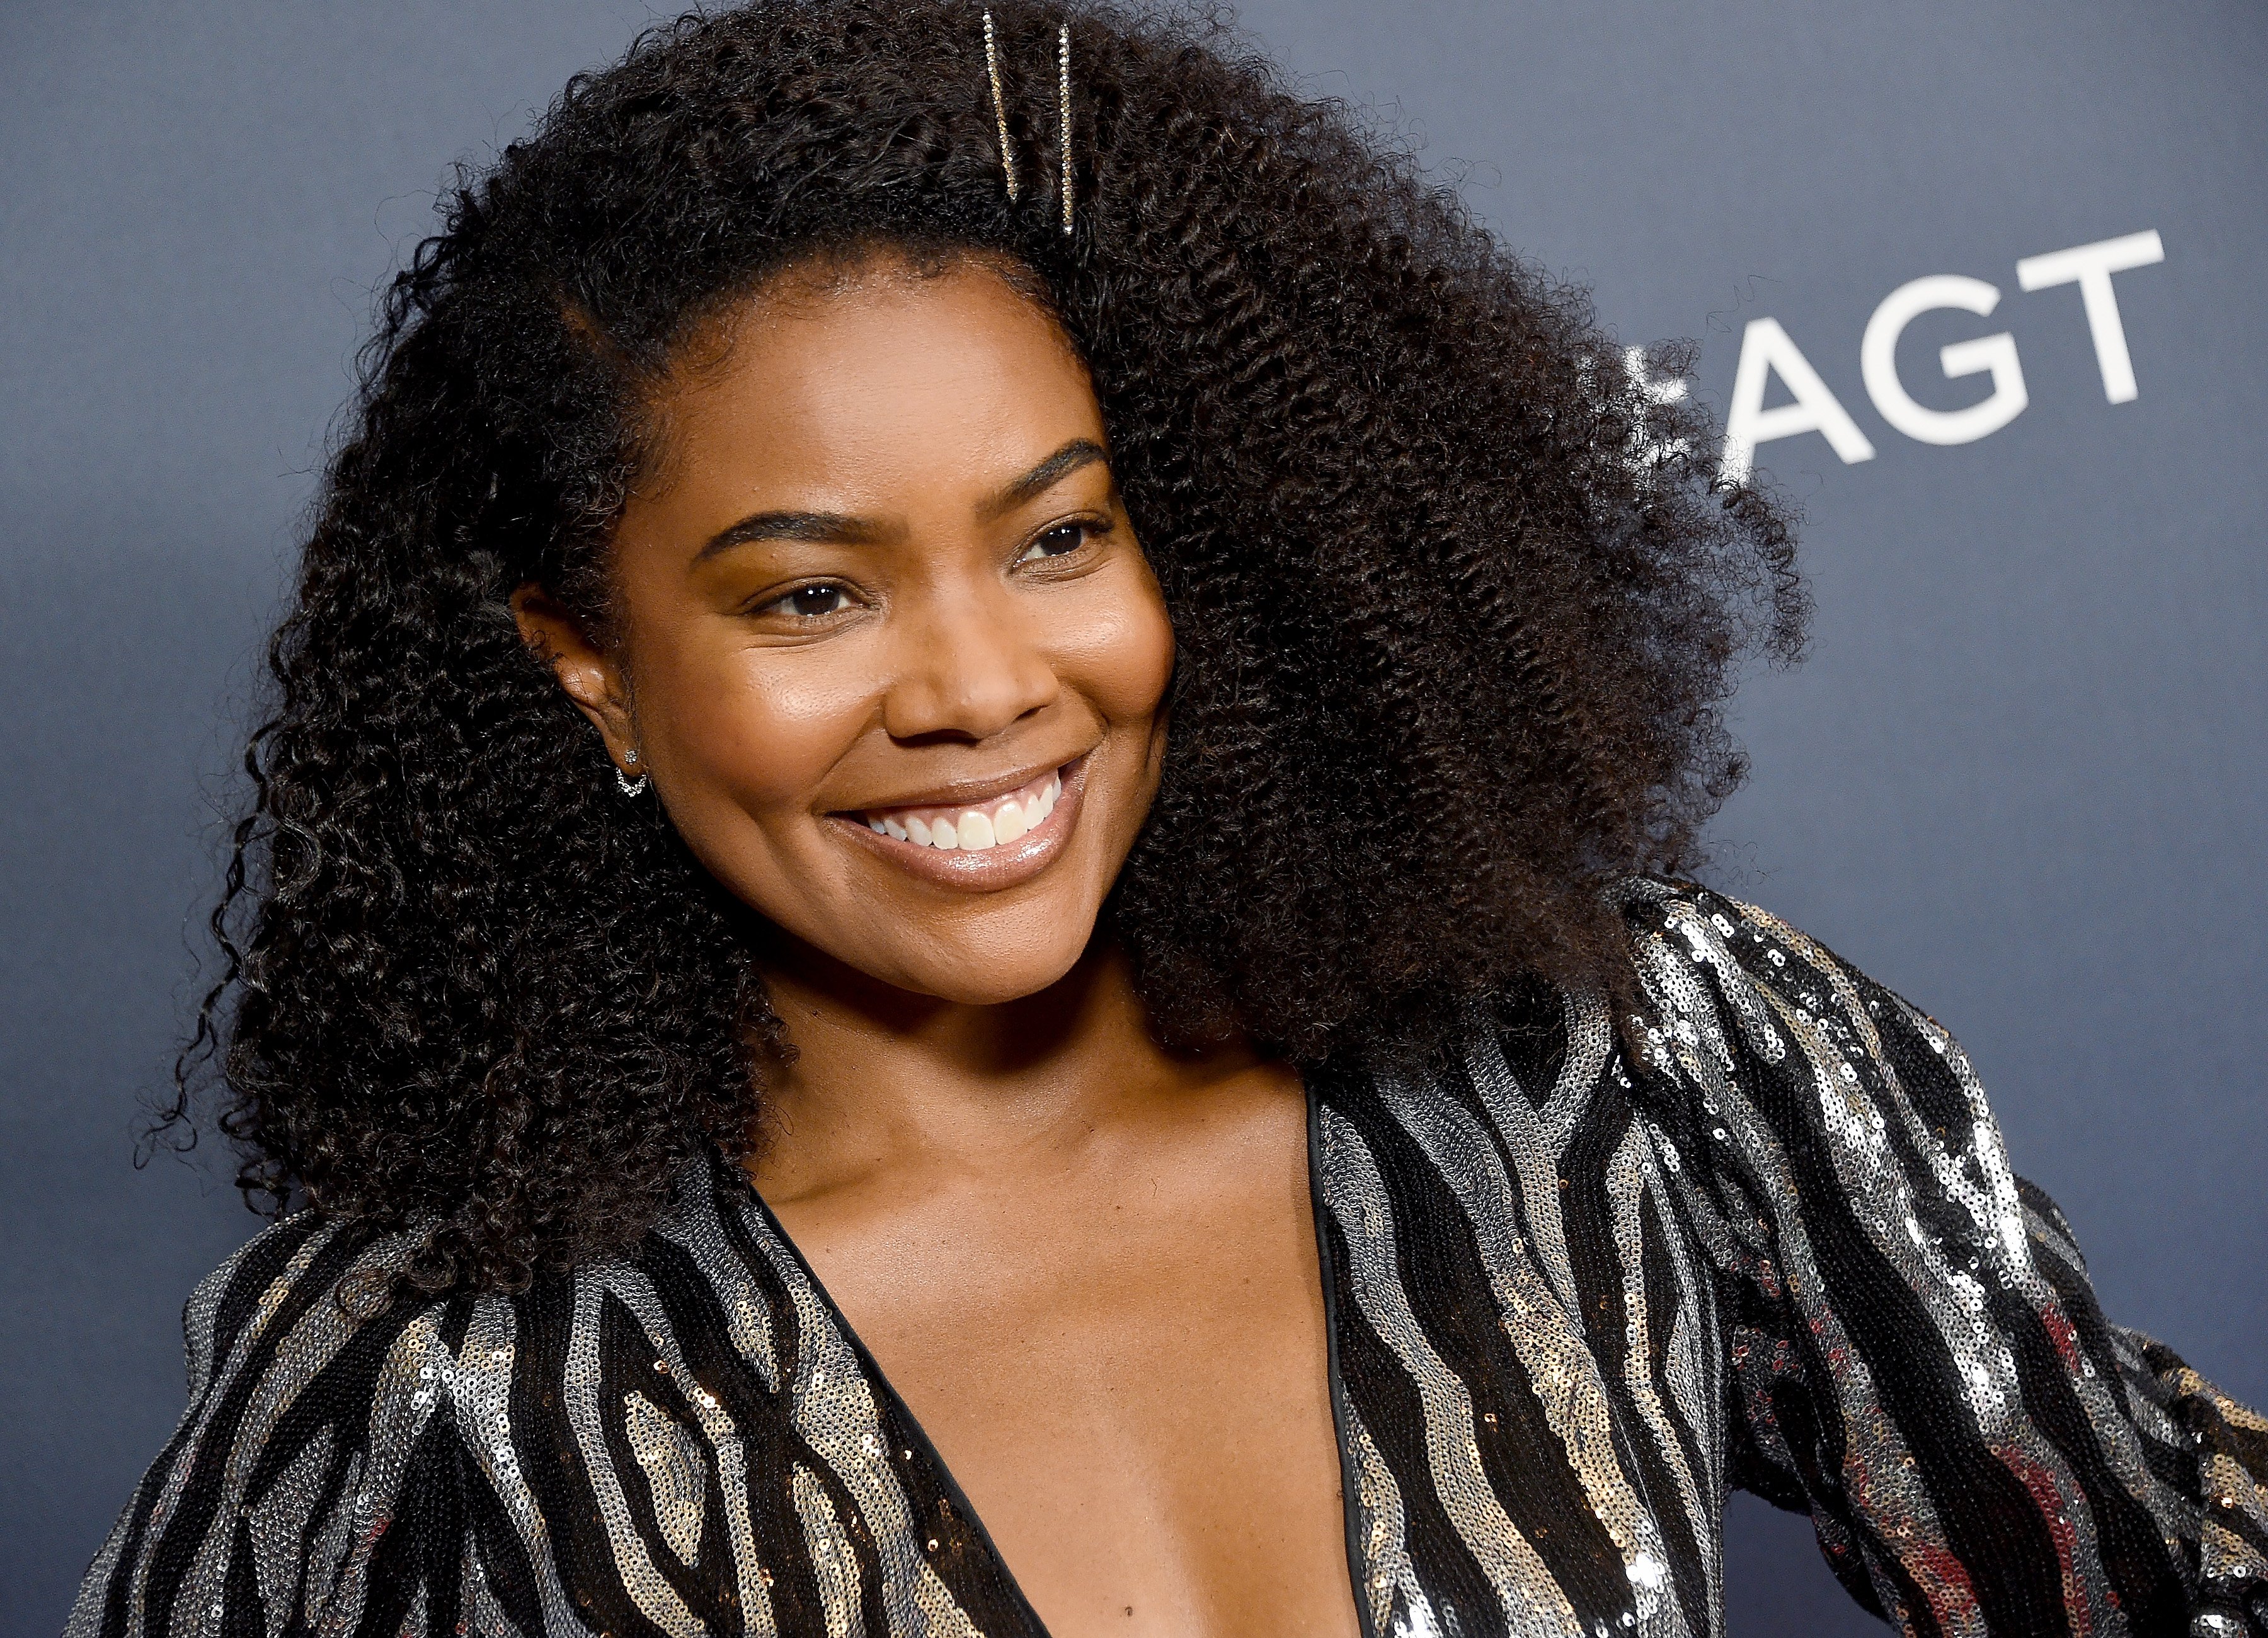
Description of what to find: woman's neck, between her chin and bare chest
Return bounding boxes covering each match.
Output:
[748,939,1254,1203]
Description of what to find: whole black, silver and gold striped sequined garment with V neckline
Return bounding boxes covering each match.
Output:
[68,883,2268,1638]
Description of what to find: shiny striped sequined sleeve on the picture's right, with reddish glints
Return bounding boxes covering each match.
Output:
[1630,885,2268,1638]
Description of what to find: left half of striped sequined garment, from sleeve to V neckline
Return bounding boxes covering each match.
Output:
[71,1155,1043,1638]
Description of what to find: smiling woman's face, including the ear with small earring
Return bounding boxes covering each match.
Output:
[515,261,1172,1003]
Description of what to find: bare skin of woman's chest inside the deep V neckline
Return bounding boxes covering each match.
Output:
[762,1084,1358,1638]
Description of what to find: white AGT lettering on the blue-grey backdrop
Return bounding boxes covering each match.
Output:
[1678,229,2166,481]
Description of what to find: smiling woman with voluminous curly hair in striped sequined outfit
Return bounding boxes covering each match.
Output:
[71,0,2268,1638]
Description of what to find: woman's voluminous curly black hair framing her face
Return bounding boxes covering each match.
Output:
[163,0,1806,1288]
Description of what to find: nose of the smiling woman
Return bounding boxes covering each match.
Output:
[882,588,1062,740]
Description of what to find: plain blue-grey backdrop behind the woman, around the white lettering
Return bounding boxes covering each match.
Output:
[0,0,2268,1635]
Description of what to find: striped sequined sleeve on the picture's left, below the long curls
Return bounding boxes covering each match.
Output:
[66,1214,526,1638]
